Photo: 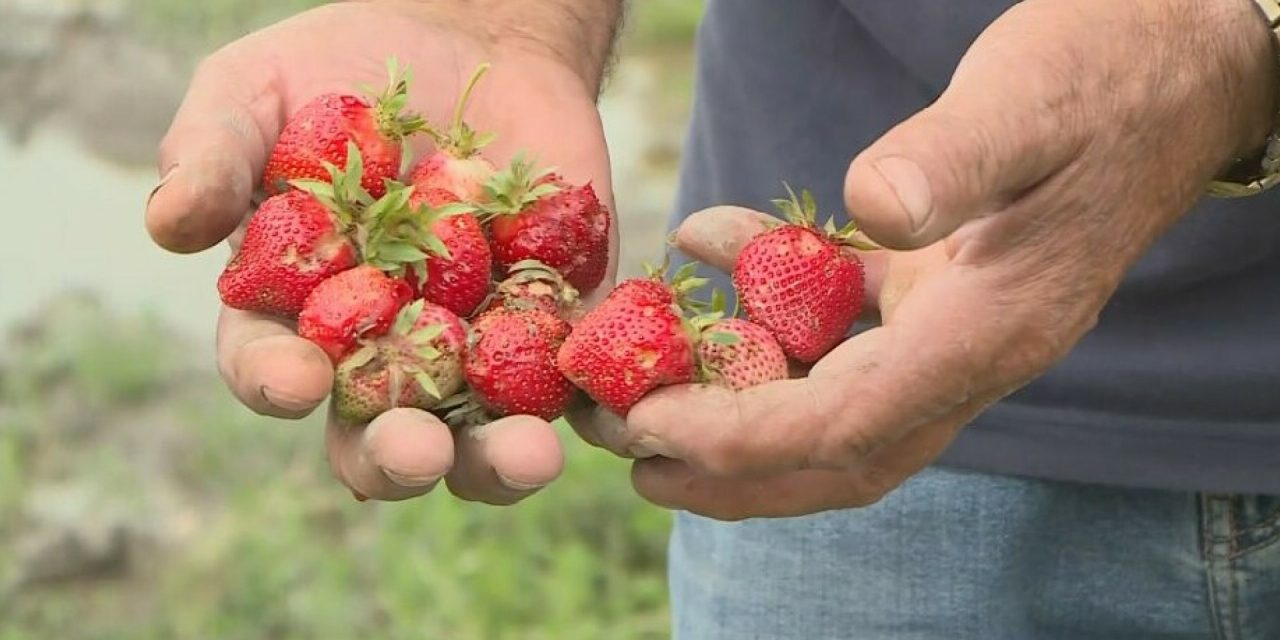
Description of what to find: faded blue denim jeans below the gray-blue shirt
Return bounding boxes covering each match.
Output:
[669,465,1280,640]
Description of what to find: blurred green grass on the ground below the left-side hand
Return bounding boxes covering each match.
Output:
[0,300,669,640]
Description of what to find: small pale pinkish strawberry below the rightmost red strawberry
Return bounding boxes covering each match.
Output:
[698,317,787,390]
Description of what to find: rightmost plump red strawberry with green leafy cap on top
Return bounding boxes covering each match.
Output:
[733,187,874,364]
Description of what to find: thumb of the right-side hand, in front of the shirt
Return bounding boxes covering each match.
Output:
[845,14,1084,250]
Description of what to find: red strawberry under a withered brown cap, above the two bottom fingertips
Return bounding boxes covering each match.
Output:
[465,308,573,420]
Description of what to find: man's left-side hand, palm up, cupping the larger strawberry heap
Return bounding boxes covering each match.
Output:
[146,0,618,504]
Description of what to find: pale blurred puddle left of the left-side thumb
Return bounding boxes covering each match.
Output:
[0,129,227,339]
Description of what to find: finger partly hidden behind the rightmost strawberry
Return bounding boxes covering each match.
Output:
[675,206,888,307]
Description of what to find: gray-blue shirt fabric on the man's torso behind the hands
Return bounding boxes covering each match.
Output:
[672,0,1280,494]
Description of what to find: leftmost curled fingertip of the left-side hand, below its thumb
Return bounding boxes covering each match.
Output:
[218,307,333,419]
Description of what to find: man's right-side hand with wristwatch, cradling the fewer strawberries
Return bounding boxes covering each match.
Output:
[576,0,1277,518]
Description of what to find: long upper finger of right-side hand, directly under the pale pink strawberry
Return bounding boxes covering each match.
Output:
[627,270,1039,477]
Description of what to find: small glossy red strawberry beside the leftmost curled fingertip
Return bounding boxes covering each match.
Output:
[298,265,412,364]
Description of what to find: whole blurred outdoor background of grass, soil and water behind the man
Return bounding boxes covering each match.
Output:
[0,0,701,640]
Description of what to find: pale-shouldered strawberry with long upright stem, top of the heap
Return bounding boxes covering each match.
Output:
[408,64,495,206]
